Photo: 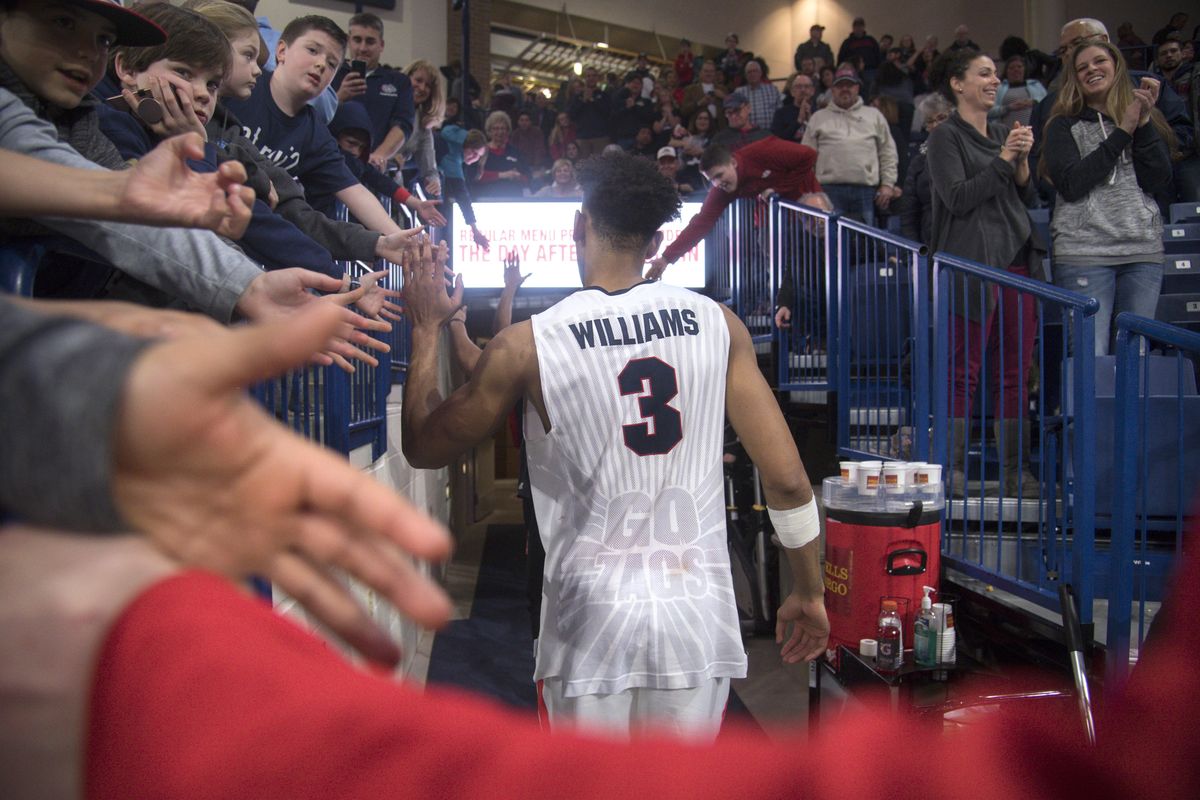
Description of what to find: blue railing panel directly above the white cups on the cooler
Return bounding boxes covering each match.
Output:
[830,217,930,461]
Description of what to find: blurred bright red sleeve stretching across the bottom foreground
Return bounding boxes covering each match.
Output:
[86,537,1200,800]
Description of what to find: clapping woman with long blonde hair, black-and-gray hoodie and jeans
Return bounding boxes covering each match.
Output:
[1038,42,1174,355]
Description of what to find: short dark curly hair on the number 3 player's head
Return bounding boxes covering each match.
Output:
[577,152,679,249]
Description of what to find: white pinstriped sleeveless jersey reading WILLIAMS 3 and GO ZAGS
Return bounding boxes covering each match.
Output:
[524,282,746,697]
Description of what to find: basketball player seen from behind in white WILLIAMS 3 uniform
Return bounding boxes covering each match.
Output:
[402,154,829,741]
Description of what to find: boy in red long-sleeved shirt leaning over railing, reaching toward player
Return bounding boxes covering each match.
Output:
[646,137,821,279]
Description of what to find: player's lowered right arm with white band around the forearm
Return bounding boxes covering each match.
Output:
[724,308,829,663]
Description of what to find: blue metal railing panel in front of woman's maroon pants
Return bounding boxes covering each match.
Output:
[932,253,1098,625]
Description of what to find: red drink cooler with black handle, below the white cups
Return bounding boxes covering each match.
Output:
[824,500,942,668]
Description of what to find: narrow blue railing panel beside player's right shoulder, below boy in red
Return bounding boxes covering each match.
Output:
[770,197,838,391]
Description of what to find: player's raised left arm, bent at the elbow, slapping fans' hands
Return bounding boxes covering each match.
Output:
[401,237,545,469]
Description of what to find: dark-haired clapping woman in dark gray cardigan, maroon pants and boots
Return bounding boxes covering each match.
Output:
[928,49,1044,498]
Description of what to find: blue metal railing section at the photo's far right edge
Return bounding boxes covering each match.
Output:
[1105,313,1200,685]
